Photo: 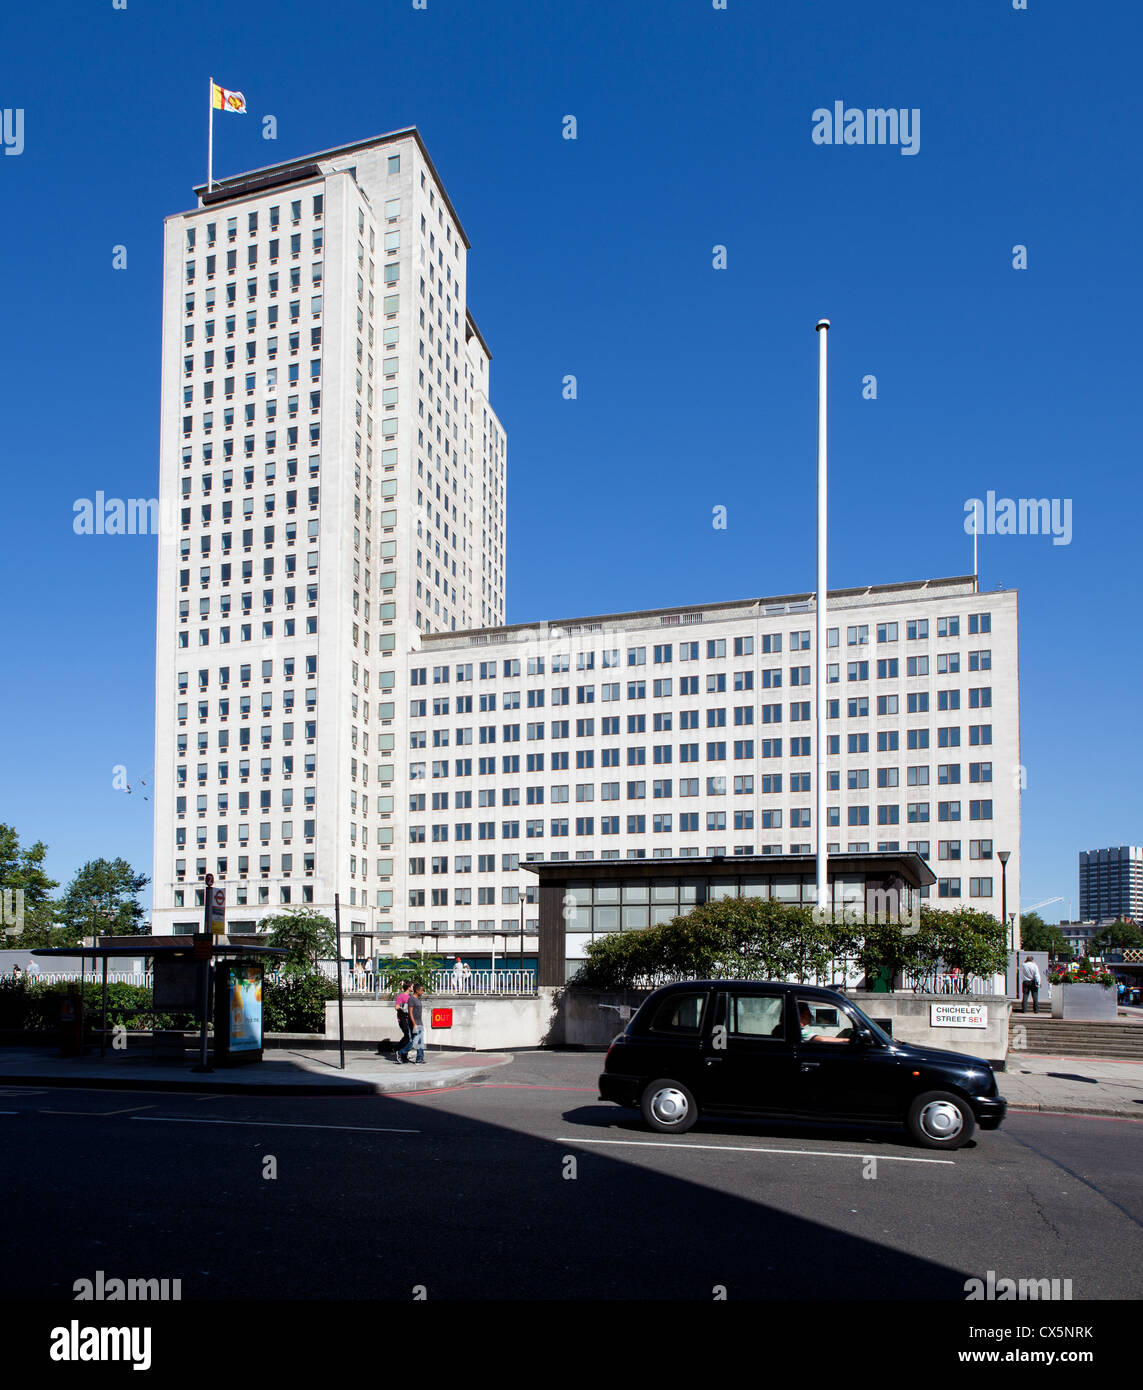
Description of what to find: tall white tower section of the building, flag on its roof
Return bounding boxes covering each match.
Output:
[153,129,506,931]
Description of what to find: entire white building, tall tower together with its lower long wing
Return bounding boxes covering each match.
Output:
[153,129,1023,959]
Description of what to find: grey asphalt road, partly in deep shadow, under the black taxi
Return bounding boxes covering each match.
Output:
[0,1054,1143,1301]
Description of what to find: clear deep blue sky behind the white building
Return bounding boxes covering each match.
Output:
[0,0,1143,920]
